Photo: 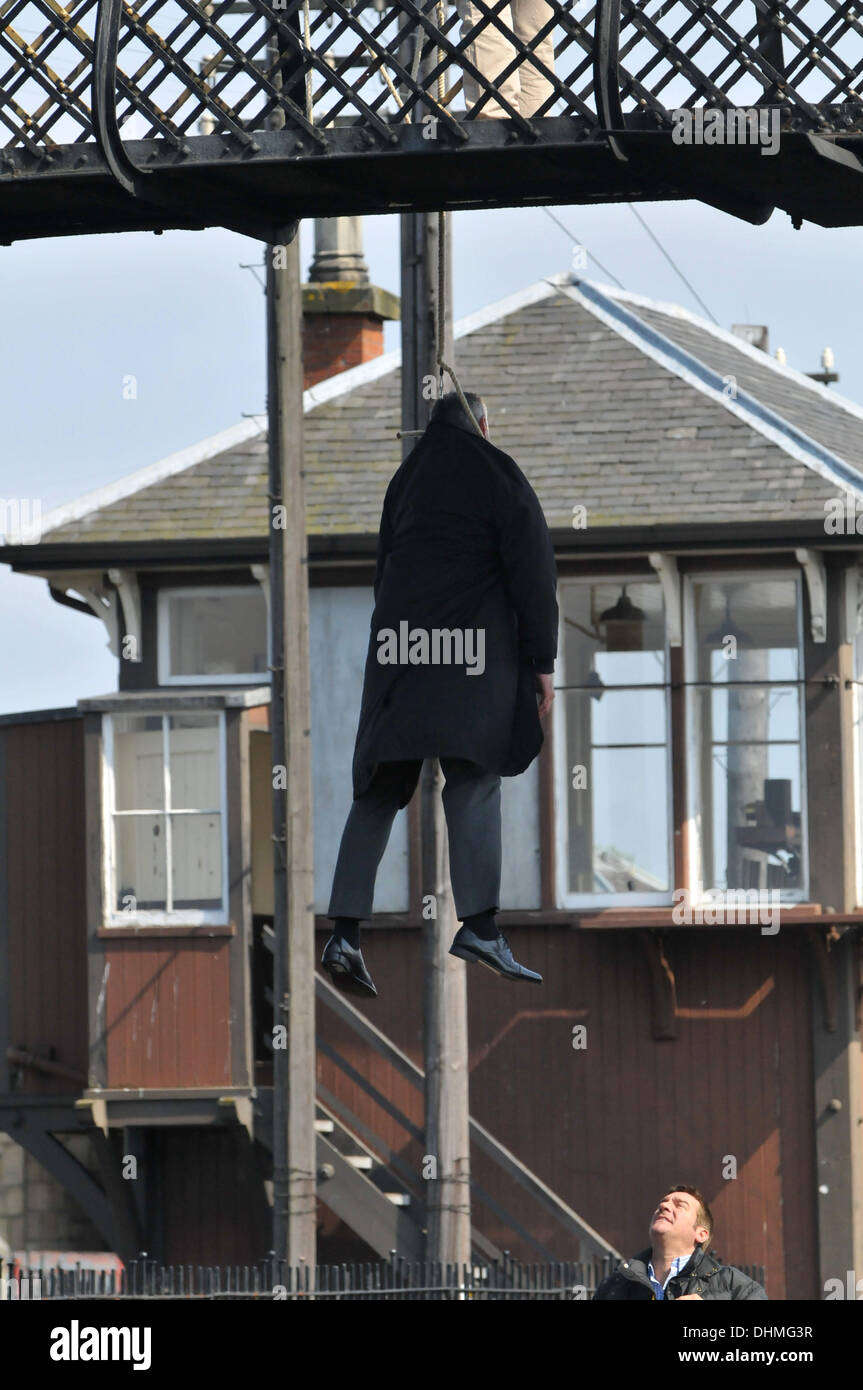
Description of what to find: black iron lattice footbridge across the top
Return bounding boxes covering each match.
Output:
[0,0,863,243]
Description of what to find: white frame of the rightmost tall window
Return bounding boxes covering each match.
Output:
[684,567,809,906]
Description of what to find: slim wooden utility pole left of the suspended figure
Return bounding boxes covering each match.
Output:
[267,224,317,1266]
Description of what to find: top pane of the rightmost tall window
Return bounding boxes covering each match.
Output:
[692,577,800,681]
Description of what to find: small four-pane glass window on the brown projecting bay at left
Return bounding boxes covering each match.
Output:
[106,713,227,926]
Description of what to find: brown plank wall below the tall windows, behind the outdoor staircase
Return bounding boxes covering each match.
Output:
[318,927,819,1298]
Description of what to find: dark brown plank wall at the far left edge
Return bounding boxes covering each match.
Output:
[0,719,88,1095]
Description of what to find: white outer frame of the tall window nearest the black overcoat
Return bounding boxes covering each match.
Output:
[553,571,674,910]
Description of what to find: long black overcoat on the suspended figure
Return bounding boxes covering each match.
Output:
[353,421,557,806]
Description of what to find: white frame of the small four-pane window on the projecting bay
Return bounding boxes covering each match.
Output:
[101,706,229,927]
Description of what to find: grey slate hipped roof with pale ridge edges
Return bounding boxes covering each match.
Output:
[33,274,863,543]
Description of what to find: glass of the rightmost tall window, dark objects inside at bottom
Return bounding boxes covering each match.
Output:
[688,574,806,897]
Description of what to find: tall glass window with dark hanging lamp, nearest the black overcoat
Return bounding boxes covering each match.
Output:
[556,578,673,905]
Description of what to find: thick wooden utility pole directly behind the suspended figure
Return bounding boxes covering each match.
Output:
[402,213,471,1264]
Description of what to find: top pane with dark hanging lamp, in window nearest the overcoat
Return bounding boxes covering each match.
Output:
[560,580,666,687]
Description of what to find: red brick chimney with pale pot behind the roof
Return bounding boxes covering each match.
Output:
[303,217,400,388]
